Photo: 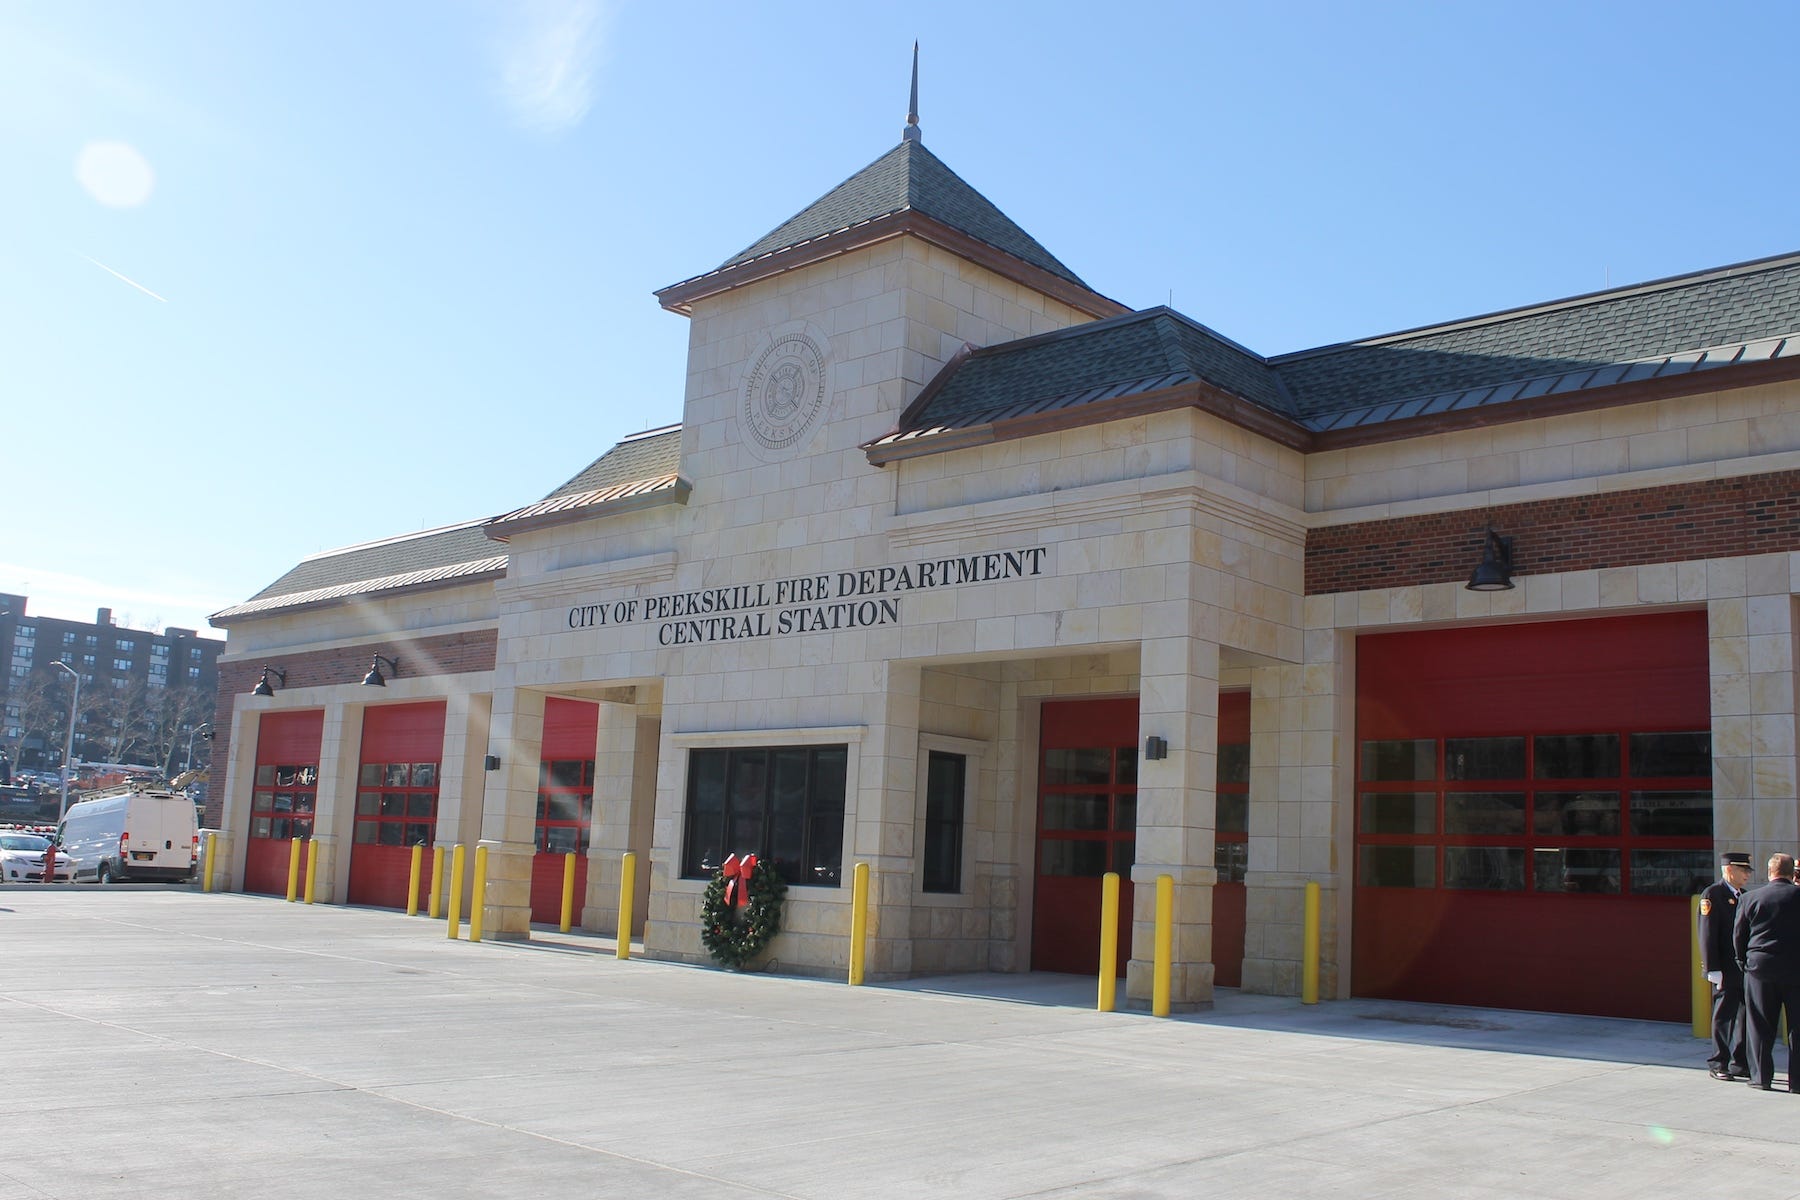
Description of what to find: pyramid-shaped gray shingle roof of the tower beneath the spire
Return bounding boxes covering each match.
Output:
[718,142,1087,288]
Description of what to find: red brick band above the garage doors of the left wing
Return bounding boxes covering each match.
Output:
[207,630,500,829]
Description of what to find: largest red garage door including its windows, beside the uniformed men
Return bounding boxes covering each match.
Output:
[1352,612,1714,1020]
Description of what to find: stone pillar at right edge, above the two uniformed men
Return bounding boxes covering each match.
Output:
[1706,554,1800,867]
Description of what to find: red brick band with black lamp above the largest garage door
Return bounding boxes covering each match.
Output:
[1307,471,1800,596]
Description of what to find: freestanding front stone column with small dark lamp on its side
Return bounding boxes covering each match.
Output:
[1125,637,1219,1009]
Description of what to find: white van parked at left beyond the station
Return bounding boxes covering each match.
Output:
[56,790,200,883]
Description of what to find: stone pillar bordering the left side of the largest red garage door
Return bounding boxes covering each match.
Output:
[1244,628,1355,997]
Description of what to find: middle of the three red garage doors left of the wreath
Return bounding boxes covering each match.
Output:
[349,700,445,909]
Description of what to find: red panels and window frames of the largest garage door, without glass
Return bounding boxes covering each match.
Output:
[1352,612,1712,1020]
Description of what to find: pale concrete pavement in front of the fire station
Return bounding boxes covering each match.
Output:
[0,885,1800,1200]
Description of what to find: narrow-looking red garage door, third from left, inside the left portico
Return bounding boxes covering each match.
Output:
[531,696,599,925]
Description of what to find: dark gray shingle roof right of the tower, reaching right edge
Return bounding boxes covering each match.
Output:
[882,255,1800,441]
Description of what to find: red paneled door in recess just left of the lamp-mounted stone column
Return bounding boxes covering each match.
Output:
[1031,696,1138,975]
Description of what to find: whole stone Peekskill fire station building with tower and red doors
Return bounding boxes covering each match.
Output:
[209,112,1800,1020]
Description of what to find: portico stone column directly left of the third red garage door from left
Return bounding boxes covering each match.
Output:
[472,687,544,941]
